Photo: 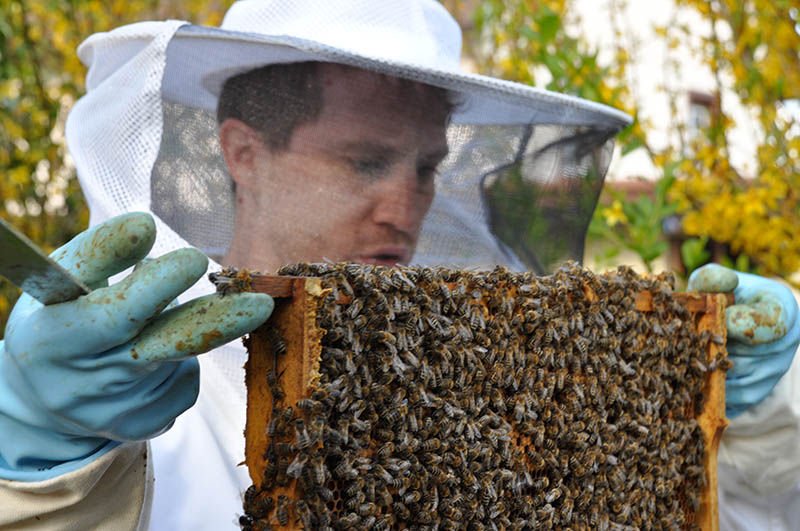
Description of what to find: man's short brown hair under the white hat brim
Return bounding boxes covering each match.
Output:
[217,61,456,152]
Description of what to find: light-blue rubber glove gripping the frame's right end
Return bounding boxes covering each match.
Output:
[688,264,800,418]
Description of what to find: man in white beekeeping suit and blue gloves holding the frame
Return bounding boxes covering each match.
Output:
[0,0,800,529]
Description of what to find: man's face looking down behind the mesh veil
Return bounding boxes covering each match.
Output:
[225,65,447,270]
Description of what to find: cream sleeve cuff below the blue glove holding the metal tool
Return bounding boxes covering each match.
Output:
[0,442,153,531]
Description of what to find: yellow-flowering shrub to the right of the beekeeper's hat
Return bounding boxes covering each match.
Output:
[444,0,800,287]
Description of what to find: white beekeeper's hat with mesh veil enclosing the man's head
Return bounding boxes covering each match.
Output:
[67,0,629,273]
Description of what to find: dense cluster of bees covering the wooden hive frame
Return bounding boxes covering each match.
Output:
[240,263,725,531]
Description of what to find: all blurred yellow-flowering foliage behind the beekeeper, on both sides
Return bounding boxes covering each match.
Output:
[0,0,800,330]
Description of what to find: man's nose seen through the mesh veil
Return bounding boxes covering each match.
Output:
[373,171,433,234]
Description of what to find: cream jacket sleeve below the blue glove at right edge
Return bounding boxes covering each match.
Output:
[719,355,800,498]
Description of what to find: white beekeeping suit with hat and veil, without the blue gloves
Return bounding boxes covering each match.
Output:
[0,0,800,529]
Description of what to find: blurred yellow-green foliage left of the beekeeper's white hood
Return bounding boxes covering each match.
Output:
[0,0,232,337]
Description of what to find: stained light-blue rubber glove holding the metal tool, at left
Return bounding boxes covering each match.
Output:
[0,213,273,481]
